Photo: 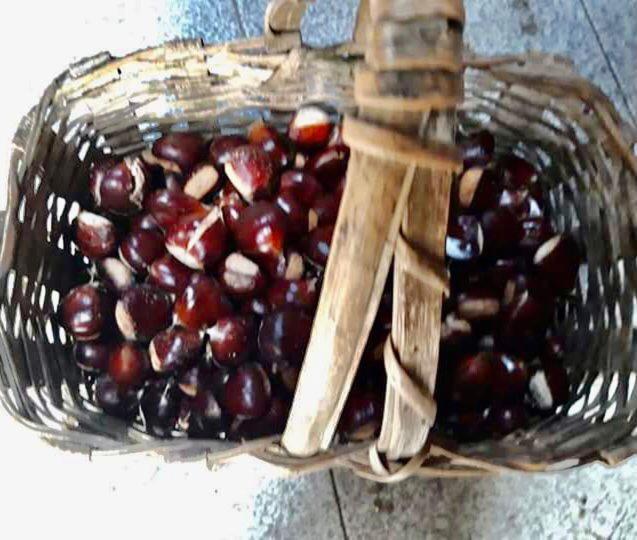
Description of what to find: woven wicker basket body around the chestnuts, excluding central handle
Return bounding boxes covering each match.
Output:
[0,0,637,481]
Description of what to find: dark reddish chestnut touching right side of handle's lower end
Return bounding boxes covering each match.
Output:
[451,353,493,406]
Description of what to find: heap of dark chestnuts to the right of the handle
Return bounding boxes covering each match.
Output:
[436,131,580,441]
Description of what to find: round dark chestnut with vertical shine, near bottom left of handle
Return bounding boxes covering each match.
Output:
[223,363,272,418]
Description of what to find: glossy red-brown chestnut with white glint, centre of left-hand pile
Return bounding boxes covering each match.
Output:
[174,273,233,330]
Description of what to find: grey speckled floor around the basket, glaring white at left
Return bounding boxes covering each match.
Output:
[0,0,637,540]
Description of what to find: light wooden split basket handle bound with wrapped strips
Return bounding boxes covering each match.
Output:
[282,0,462,464]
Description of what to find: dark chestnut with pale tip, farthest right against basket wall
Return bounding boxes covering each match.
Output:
[533,234,580,294]
